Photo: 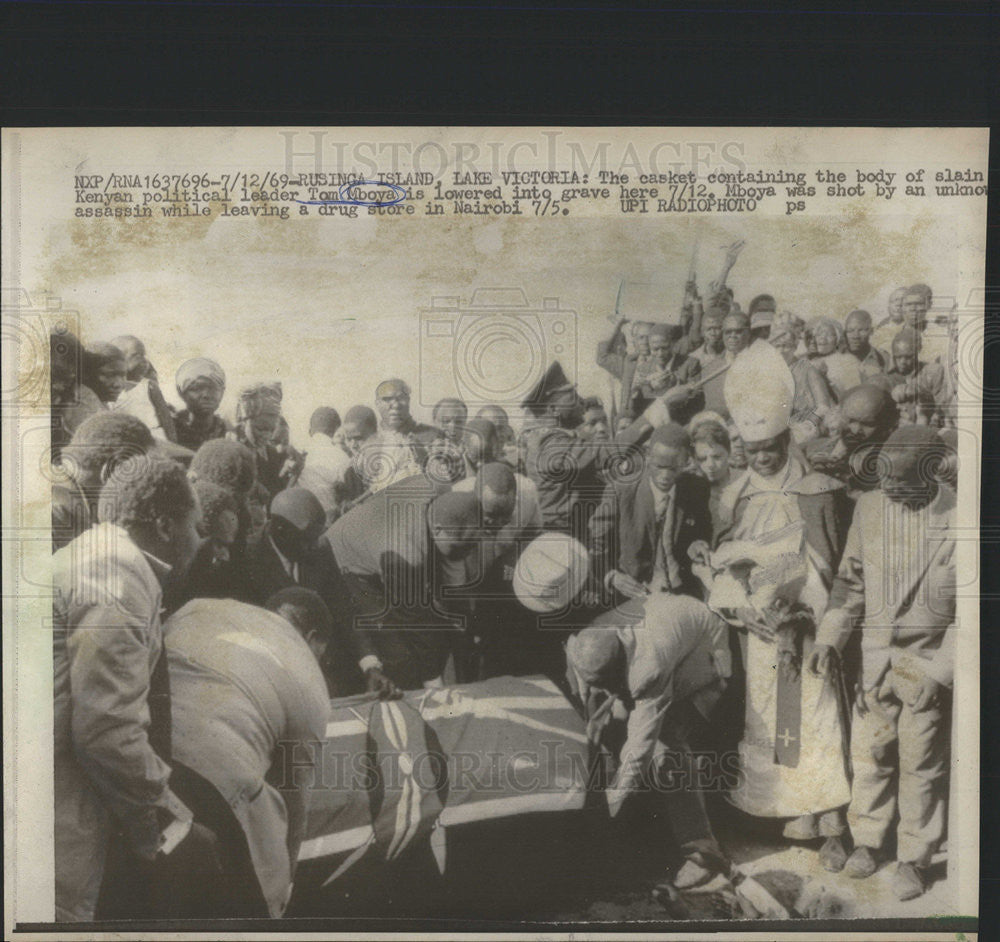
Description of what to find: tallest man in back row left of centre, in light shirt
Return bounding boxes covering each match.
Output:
[358,379,438,493]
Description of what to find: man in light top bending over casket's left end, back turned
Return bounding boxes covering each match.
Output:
[163,586,333,918]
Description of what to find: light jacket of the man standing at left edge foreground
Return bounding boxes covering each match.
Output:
[52,523,191,922]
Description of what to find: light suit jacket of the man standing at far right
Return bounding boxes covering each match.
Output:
[816,485,955,690]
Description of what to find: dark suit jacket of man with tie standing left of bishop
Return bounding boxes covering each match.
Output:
[590,472,712,597]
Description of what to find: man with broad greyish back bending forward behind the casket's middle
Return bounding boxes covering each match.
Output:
[326,472,515,694]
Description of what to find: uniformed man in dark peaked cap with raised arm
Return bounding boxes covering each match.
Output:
[522,361,617,542]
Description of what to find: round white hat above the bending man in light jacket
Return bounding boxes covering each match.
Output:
[514,532,589,613]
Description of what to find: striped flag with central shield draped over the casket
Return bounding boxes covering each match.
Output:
[299,677,589,883]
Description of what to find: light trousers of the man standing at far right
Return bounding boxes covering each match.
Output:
[847,667,950,866]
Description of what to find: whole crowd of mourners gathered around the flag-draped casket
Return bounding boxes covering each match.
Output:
[51,247,957,921]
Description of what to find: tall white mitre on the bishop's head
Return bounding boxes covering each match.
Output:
[725,340,795,442]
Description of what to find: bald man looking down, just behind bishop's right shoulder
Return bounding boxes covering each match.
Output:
[803,384,899,499]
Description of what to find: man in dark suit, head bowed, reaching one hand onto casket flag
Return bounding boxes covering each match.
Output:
[242,487,378,696]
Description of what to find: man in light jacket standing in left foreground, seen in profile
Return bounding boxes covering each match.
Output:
[53,458,206,922]
